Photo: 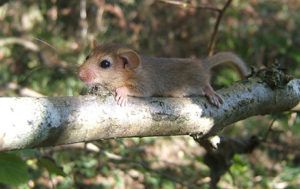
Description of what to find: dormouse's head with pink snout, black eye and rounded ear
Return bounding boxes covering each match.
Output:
[79,44,141,88]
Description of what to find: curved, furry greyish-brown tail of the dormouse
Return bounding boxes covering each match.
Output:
[204,52,250,78]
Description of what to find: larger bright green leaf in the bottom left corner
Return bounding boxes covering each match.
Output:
[0,153,29,185]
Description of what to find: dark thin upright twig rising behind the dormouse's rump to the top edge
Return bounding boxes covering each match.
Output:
[208,0,232,56]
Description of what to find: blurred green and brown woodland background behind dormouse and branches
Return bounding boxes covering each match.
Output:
[0,0,300,189]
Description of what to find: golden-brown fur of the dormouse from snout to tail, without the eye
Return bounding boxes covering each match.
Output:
[79,44,247,106]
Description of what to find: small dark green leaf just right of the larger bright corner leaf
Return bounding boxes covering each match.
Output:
[37,157,66,176]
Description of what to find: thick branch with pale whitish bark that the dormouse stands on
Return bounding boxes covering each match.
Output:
[0,79,300,151]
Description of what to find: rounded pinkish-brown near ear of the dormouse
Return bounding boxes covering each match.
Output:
[118,48,141,69]
